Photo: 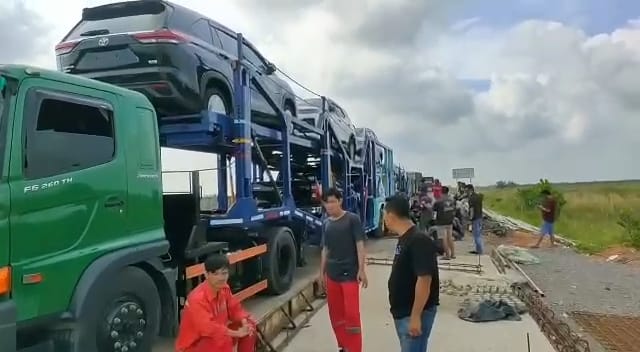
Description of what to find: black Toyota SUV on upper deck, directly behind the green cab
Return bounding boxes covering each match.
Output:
[56,0,296,125]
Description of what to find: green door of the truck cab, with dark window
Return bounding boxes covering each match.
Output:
[10,78,127,320]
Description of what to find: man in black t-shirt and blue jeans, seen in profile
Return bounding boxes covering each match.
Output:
[384,196,440,352]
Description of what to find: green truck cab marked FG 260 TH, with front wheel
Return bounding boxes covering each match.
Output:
[0,65,178,352]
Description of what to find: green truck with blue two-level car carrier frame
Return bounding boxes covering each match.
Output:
[0,34,395,352]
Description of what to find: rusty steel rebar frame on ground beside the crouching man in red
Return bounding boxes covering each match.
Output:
[256,280,326,352]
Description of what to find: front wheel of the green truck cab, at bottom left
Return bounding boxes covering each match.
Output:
[53,267,161,352]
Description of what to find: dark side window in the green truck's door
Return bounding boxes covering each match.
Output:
[24,98,115,179]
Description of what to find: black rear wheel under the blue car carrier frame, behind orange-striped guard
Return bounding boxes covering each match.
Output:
[262,227,297,295]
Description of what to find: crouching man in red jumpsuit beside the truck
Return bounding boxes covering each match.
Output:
[176,254,256,352]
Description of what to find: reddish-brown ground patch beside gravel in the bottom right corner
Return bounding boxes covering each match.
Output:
[571,312,640,352]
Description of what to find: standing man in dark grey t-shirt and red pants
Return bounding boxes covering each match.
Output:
[318,188,367,352]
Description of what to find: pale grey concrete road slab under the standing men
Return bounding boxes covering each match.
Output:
[283,240,554,352]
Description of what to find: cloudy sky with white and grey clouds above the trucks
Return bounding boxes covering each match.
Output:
[0,0,640,190]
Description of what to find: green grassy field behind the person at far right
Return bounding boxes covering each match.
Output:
[481,181,640,252]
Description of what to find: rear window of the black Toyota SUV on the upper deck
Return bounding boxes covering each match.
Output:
[64,1,167,41]
